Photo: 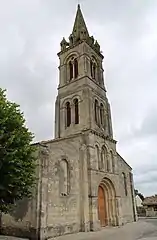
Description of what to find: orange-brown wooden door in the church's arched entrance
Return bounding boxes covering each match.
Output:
[98,186,106,227]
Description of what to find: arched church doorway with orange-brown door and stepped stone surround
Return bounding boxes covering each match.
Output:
[98,178,117,227]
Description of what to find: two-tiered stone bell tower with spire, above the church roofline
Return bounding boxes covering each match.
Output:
[55,5,113,139]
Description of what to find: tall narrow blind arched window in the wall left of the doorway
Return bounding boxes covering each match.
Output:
[59,159,69,196]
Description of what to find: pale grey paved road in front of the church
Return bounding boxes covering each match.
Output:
[0,218,157,240]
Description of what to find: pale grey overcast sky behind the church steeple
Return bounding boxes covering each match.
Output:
[0,0,157,195]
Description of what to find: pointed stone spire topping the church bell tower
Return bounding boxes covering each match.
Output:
[72,4,89,40]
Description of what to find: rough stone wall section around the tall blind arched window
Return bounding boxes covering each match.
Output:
[42,137,83,239]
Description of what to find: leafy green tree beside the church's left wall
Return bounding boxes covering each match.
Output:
[0,89,36,213]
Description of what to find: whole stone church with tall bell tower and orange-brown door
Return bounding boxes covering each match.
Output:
[2,5,136,240]
